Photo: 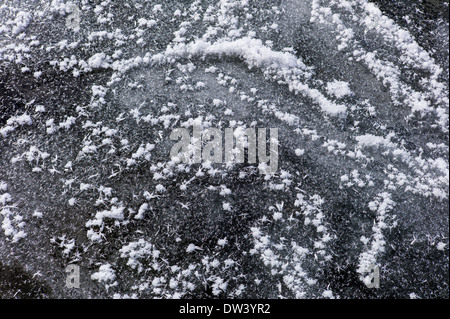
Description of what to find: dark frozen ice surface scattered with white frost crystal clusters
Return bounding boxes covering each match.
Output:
[0,0,449,298]
